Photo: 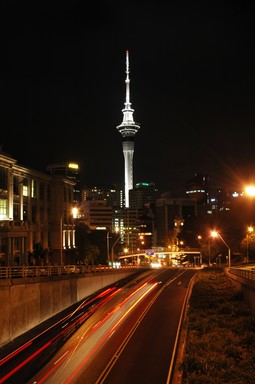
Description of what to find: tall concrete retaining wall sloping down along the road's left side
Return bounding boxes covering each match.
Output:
[0,270,136,347]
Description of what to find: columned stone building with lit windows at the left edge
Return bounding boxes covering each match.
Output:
[0,152,75,266]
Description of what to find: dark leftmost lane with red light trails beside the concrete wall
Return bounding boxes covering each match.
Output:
[0,270,150,384]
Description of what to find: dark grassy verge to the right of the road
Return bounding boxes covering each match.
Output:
[178,268,255,384]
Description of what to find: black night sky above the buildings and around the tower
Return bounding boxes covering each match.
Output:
[0,0,255,194]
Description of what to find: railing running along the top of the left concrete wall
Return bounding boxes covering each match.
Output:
[0,265,139,279]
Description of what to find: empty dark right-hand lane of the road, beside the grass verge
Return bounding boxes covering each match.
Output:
[97,270,196,384]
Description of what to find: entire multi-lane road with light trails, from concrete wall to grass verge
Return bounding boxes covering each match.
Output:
[0,268,196,384]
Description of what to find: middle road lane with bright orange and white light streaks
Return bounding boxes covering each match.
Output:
[26,270,170,383]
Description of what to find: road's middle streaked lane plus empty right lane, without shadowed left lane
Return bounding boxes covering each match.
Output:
[28,269,196,384]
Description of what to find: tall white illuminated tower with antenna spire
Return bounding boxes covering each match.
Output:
[116,51,140,208]
